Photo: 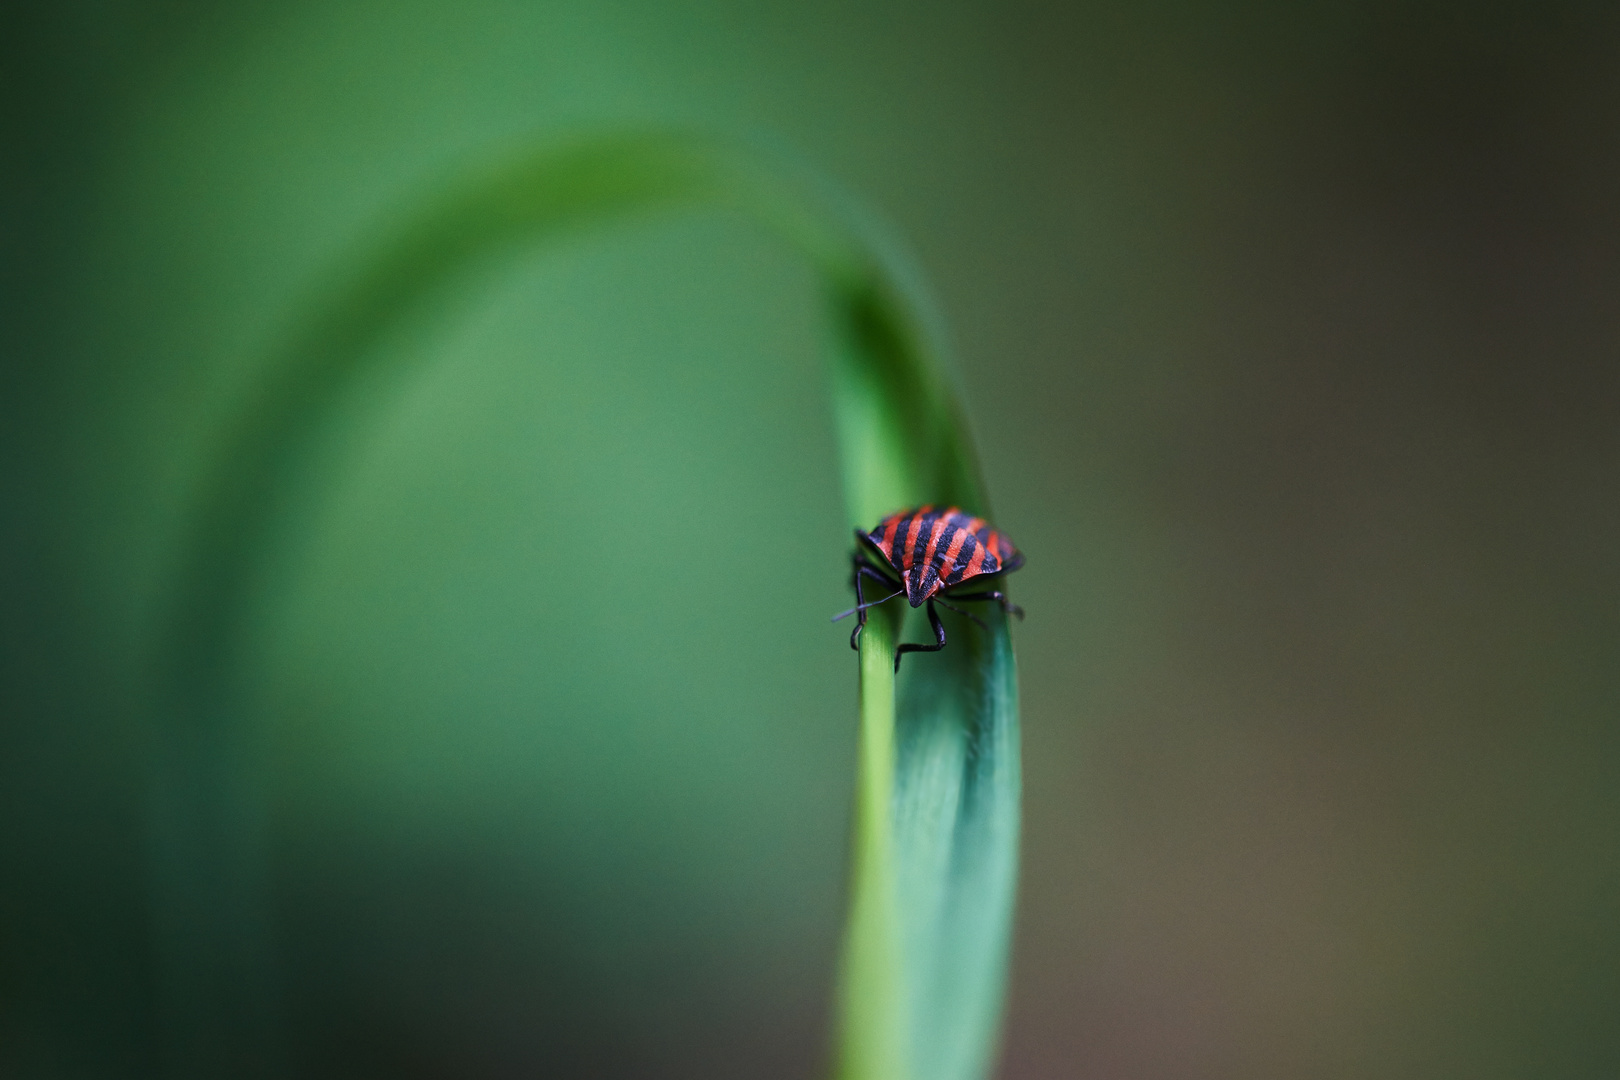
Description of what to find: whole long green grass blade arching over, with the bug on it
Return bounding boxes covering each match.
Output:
[164,134,1019,1080]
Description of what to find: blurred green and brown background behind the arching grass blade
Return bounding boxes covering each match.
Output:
[9,0,1620,1080]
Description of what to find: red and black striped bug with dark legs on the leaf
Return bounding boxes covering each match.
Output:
[833,507,1024,670]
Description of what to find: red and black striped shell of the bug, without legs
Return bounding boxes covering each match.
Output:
[867,507,1024,607]
